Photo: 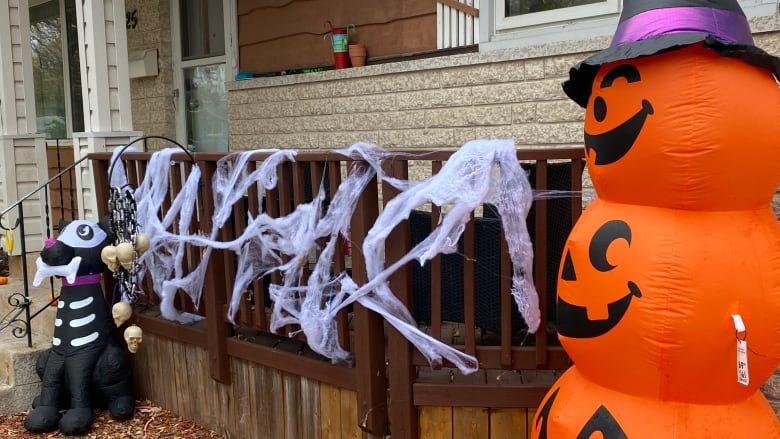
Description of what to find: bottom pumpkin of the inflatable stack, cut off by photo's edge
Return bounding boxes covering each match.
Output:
[532,366,780,439]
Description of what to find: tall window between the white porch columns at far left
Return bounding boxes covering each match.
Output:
[30,0,84,139]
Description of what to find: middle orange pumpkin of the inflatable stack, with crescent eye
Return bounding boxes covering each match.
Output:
[557,200,780,403]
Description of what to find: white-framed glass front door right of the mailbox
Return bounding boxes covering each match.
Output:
[171,0,234,152]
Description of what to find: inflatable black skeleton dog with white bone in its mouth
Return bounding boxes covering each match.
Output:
[24,220,135,435]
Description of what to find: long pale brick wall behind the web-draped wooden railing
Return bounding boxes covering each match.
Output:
[228,54,583,154]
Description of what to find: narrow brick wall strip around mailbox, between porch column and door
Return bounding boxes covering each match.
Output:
[125,0,176,147]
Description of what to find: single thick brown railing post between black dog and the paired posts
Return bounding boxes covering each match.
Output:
[198,161,234,384]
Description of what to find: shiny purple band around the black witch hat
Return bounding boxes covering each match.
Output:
[611,6,753,47]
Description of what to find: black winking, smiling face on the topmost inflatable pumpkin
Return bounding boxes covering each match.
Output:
[585,64,653,165]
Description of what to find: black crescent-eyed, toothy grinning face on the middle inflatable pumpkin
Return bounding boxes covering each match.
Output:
[558,220,642,338]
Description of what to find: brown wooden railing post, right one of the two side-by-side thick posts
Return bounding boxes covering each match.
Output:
[382,160,419,438]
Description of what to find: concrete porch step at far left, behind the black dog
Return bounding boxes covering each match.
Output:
[0,328,51,416]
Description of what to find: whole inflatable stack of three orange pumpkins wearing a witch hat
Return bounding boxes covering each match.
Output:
[533,0,780,439]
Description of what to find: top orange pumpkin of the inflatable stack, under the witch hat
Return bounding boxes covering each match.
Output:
[584,45,780,210]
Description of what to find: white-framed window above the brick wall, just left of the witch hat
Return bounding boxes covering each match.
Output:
[494,0,620,30]
